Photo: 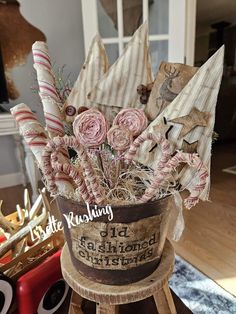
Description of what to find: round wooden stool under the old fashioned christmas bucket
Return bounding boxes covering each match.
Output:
[61,240,176,314]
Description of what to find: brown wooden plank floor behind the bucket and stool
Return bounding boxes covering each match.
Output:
[0,144,236,295]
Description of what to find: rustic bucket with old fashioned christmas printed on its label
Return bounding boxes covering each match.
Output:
[57,196,172,285]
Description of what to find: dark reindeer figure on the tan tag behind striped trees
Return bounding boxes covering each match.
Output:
[156,64,180,112]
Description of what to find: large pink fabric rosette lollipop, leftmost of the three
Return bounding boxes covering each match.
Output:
[73,109,108,148]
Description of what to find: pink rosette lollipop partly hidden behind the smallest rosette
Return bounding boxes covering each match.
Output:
[113,108,148,137]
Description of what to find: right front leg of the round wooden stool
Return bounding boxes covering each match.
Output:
[153,283,176,314]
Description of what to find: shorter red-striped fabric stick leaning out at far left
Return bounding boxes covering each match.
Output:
[11,103,74,193]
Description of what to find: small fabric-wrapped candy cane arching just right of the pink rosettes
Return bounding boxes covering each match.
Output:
[125,132,172,171]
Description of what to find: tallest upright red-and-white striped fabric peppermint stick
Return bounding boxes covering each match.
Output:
[32,41,64,137]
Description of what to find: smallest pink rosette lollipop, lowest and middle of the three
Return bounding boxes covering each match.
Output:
[107,125,133,152]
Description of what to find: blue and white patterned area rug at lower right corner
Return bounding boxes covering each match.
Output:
[170,256,236,314]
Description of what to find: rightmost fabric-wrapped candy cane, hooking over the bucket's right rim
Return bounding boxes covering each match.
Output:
[140,151,209,209]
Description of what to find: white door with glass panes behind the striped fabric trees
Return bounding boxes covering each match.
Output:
[82,0,196,73]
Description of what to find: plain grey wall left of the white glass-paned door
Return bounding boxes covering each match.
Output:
[0,0,84,183]
